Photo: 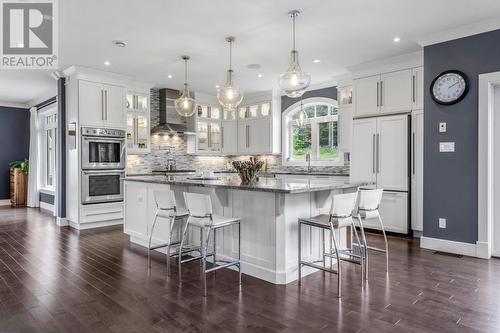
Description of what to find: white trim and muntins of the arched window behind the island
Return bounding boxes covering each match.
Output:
[281,97,344,166]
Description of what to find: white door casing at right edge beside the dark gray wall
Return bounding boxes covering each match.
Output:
[477,72,500,259]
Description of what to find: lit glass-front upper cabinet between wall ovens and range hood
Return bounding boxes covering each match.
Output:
[126,91,151,155]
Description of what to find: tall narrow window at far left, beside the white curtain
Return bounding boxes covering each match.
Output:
[39,108,57,189]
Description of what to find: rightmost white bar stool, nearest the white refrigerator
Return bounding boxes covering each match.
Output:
[357,189,389,279]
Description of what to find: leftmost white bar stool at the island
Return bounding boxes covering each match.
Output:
[148,190,188,274]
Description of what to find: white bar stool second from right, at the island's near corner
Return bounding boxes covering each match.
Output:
[299,193,364,298]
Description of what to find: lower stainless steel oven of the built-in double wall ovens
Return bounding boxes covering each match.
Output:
[81,170,125,205]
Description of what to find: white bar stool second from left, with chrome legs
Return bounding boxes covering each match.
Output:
[179,192,241,296]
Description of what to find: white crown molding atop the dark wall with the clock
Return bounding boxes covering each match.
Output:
[416,18,500,46]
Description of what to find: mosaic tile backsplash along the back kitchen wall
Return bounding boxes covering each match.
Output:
[127,89,349,174]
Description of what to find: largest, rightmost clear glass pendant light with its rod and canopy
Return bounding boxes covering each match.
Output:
[278,10,311,98]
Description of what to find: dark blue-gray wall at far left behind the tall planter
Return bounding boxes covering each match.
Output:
[0,106,30,200]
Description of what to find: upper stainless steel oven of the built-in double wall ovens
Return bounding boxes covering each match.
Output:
[82,127,126,170]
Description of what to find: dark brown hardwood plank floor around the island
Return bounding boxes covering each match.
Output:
[0,208,500,333]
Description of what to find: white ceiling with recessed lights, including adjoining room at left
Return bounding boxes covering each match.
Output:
[0,0,500,104]
